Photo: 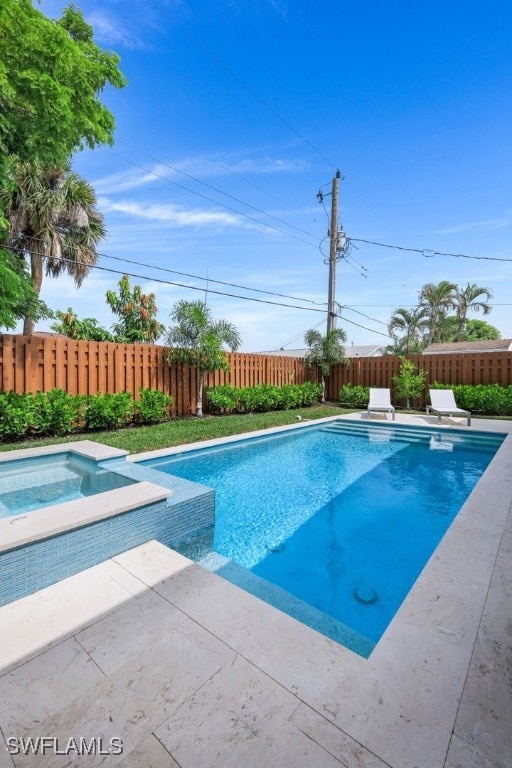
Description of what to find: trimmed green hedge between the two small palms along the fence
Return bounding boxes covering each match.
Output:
[206,381,322,414]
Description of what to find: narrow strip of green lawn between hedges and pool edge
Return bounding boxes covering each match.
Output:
[0,404,354,453]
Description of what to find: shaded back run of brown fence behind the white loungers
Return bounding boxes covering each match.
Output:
[327,352,512,407]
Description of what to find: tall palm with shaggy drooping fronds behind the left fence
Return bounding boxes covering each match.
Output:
[0,163,106,336]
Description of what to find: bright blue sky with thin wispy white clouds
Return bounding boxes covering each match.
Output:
[31,0,512,352]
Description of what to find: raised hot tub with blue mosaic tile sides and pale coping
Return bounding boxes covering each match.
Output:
[0,440,214,605]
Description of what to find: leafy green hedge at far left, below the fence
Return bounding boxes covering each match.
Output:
[0,387,173,442]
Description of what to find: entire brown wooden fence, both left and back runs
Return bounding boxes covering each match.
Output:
[0,334,512,416]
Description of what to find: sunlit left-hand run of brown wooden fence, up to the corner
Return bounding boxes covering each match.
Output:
[0,334,308,416]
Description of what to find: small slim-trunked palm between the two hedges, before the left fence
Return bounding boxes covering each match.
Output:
[166,299,242,416]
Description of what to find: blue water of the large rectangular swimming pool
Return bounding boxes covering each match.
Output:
[143,422,503,656]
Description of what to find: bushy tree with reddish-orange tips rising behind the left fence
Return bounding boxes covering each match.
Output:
[106,275,165,344]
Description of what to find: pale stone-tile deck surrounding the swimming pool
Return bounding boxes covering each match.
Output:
[0,414,512,768]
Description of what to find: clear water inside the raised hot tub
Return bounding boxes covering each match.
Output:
[0,452,135,518]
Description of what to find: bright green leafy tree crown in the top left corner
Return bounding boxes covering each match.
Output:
[0,0,126,172]
